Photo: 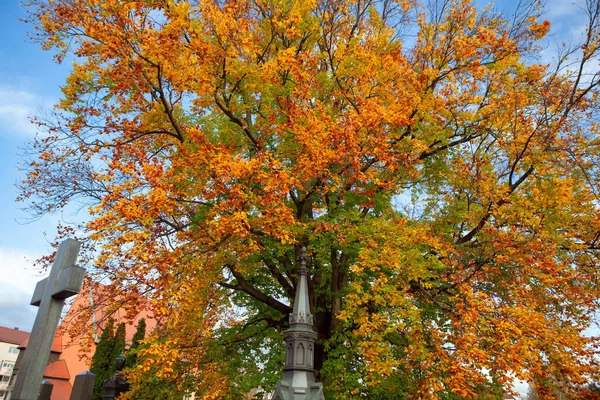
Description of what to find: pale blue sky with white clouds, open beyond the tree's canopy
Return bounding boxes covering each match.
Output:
[0,0,585,394]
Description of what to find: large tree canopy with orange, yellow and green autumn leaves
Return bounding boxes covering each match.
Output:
[21,0,600,399]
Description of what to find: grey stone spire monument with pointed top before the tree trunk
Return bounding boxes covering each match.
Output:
[272,247,325,400]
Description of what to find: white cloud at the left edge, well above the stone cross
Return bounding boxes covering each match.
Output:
[0,86,51,136]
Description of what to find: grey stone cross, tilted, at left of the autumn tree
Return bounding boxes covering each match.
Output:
[11,239,85,400]
